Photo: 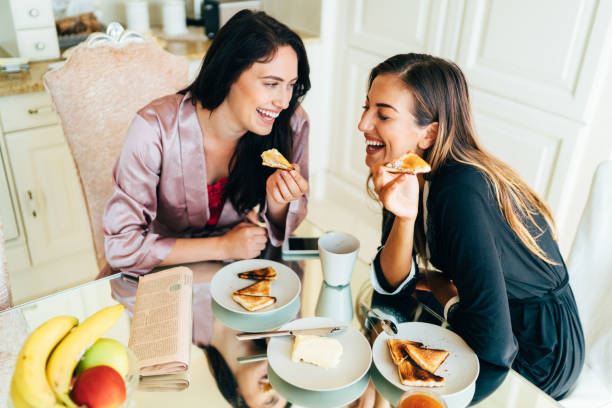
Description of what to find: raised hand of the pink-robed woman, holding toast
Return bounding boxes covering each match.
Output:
[266,164,309,209]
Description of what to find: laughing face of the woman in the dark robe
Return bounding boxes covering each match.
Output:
[358,74,437,167]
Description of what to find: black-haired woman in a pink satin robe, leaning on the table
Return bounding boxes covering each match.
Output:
[104,10,310,273]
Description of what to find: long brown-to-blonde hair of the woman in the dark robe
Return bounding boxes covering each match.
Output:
[368,53,556,264]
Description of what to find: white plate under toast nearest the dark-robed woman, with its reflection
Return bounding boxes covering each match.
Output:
[372,322,480,408]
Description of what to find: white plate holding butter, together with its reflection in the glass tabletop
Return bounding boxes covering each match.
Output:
[268,317,372,408]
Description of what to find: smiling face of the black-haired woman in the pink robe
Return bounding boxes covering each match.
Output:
[222,46,298,135]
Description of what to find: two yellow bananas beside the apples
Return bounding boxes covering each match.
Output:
[10,304,125,408]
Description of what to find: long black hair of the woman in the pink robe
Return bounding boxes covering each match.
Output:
[180,10,310,214]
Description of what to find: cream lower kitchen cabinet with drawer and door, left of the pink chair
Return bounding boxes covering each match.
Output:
[0,92,93,273]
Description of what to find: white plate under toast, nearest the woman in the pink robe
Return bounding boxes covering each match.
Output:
[210,259,302,315]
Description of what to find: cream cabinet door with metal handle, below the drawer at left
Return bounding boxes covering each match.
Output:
[6,125,91,265]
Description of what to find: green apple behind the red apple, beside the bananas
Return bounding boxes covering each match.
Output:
[74,338,129,377]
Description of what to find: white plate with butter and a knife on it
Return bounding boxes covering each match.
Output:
[268,317,372,391]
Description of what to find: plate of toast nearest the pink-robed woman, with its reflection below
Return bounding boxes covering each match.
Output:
[210,259,302,332]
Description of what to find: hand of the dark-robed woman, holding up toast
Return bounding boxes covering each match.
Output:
[372,165,419,220]
